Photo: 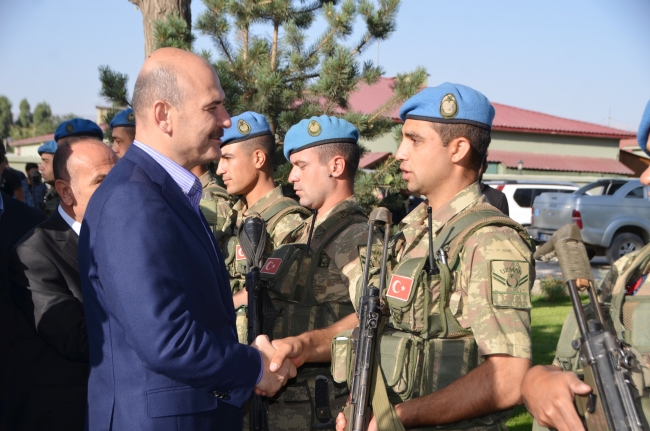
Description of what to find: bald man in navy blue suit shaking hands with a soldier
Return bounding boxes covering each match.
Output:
[79,48,295,431]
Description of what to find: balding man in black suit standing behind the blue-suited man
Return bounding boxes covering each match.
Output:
[6,138,117,431]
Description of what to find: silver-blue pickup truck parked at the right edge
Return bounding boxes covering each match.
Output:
[528,178,650,264]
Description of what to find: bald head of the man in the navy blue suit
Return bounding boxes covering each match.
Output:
[132,48,232,170]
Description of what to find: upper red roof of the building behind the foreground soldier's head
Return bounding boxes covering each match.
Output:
[349,78,636,139]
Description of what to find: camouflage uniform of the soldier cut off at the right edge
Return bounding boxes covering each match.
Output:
[534,245,650,429]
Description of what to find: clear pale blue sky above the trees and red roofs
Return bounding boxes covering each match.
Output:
[0,0,650,130]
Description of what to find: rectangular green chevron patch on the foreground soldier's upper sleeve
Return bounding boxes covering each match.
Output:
[490,260,532,309]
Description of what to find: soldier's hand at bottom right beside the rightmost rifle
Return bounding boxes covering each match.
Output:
[521,365,591,431]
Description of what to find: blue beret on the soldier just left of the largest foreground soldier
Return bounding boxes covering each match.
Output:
[284,115,359,160]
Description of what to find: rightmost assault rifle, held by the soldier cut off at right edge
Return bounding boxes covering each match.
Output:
[535,224,643,431]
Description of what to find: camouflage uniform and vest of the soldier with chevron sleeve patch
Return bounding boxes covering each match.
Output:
[346,183,535,430]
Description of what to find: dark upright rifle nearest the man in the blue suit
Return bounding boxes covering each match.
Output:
[239,213,269,431]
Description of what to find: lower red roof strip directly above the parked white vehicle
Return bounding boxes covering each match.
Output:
[488,150,634,175]
